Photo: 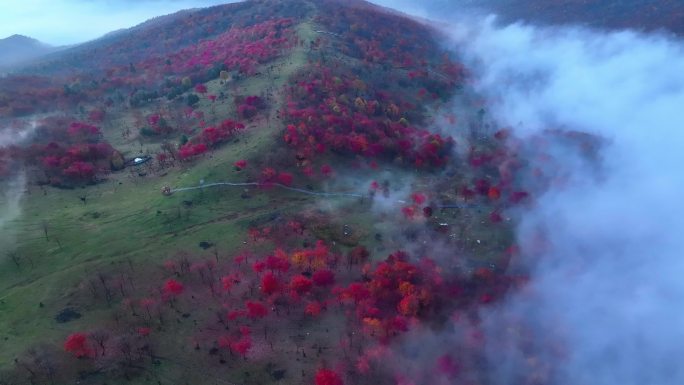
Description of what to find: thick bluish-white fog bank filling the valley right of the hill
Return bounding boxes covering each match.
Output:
[452,14,684,385]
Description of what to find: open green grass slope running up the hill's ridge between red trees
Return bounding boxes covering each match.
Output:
[0,19,314,369]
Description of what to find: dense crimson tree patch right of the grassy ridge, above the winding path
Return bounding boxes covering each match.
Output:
[283,67,454,168]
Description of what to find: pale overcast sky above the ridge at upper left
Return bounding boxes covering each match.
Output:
[0,0,234,45]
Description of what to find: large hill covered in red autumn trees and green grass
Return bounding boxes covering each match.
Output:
[0,0,536,385]
